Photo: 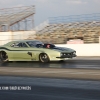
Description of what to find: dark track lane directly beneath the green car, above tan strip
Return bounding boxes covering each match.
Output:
[0,57,100,69]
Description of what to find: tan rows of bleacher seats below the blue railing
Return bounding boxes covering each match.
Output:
[31,21,100,44]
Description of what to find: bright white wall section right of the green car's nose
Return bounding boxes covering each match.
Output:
[56,44,100,56]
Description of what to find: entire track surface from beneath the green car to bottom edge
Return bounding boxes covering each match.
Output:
[0,57,100,100]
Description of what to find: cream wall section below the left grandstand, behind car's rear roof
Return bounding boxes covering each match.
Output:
[0,31,36,45]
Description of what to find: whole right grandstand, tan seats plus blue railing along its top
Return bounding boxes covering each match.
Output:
[33,13,100,44]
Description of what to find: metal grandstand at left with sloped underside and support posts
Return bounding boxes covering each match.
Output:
[0,6,35,32]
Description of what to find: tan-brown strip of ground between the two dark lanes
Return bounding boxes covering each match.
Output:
[0,67,100,80]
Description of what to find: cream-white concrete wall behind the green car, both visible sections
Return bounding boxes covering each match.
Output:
[0,31,100,56]
